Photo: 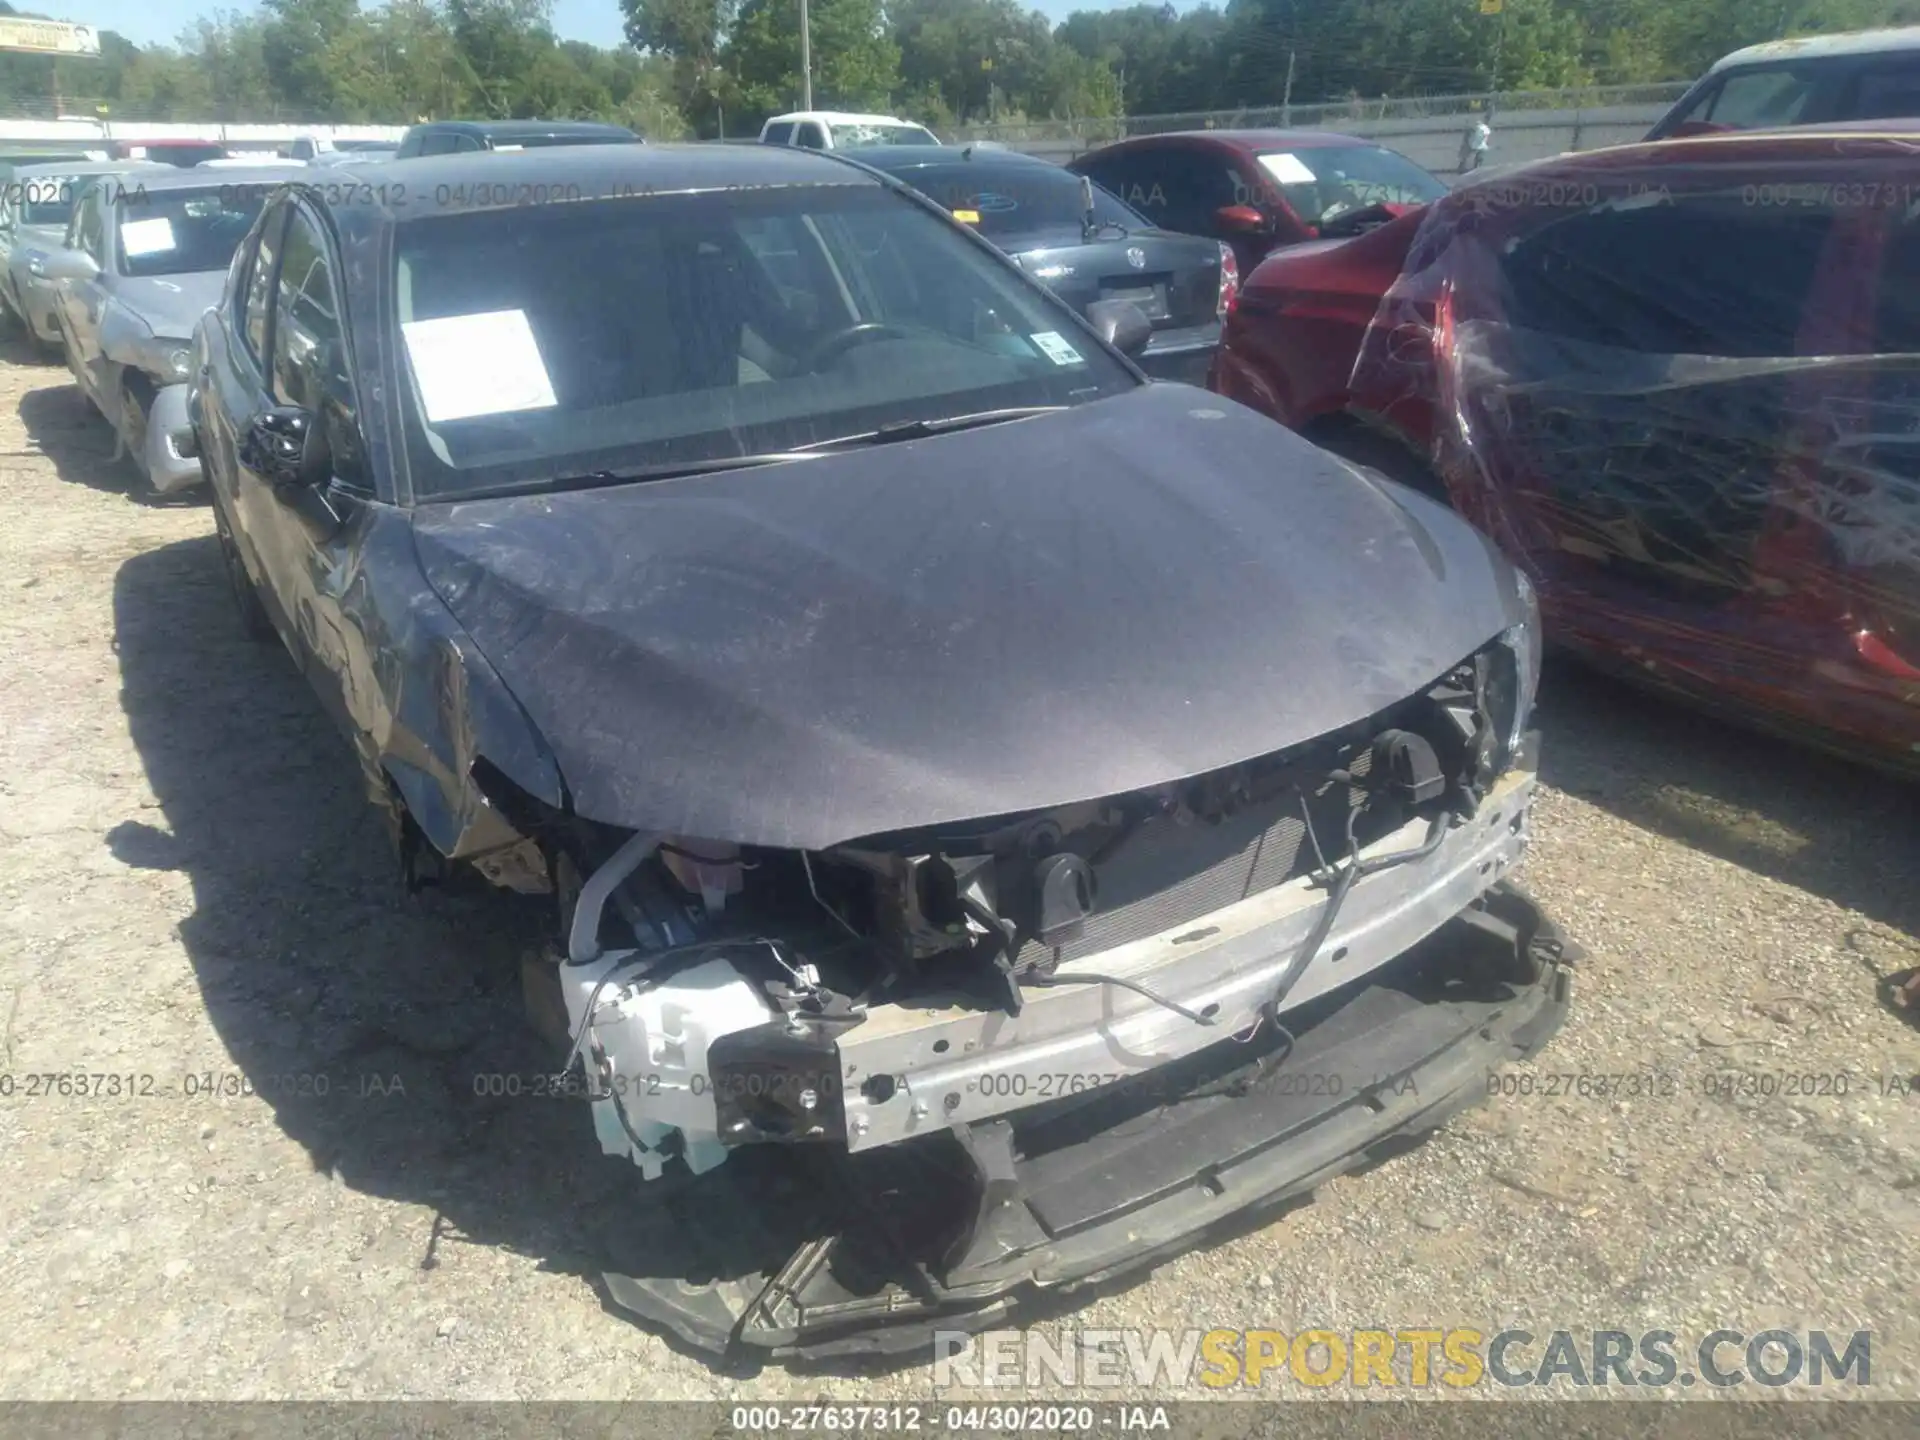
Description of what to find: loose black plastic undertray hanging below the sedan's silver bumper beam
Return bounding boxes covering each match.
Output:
[605,883,1572,1357]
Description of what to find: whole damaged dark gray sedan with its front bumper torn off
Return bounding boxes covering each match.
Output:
[192,146,1572,1356]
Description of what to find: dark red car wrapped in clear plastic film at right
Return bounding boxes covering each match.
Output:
[1210,121,1920,772]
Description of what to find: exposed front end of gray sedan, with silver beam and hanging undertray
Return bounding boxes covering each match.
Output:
[559,624,1569,1354]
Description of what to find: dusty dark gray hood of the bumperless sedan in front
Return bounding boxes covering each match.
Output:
[413,384,1521,849]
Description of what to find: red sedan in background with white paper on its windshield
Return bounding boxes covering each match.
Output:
[1068,131,1446,275]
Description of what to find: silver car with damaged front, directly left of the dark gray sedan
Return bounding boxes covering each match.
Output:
[33,165,303,493]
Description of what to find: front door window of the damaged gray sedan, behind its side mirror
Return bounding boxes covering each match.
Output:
[273,205,365,486]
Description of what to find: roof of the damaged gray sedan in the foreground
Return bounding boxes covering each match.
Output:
[316,144,883,225]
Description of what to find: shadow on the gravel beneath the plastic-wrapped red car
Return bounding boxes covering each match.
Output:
[1540,659,1920,973]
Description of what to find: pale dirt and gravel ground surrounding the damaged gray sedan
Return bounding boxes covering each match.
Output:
[0,332,1920,1400]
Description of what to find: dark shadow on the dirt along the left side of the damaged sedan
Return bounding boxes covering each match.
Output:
[106,536,1059,1373]
